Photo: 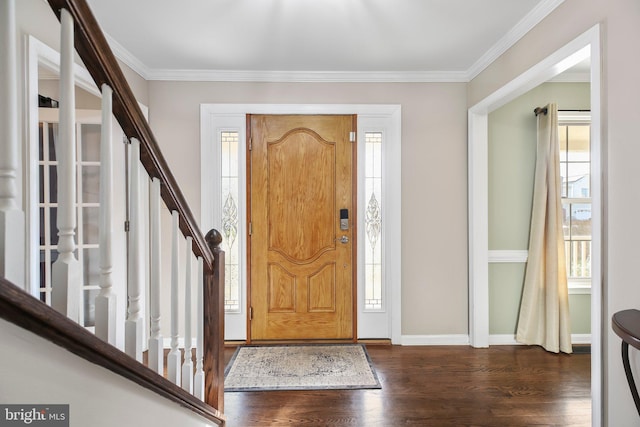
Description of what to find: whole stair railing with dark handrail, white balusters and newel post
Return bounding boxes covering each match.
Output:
[0,0,224,424]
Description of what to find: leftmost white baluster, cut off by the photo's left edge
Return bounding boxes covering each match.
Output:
[0,0,26,286]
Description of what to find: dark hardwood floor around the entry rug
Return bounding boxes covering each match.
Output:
[224,346,591,427]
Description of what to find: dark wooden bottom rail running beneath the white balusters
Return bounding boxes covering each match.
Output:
[0,277,225,425]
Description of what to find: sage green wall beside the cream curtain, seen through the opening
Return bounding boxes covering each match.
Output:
[489,83,591,335]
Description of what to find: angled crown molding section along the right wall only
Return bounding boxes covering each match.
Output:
[467,0,564,81]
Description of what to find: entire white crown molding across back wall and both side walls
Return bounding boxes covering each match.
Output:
[105,0,564,83]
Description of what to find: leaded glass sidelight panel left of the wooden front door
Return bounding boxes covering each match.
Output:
[220,131,241,312]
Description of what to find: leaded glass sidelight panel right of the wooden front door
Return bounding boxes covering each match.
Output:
[364,132,384,311]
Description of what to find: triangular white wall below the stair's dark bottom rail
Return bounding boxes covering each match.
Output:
[0,319,214,427]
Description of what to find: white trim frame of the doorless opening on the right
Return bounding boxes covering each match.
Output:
[468,25,603,426]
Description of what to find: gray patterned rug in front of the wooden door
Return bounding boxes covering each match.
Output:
[224,344,381,391]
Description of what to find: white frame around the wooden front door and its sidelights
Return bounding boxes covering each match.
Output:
[200,104,402,344]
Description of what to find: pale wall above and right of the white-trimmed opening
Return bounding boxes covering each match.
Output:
[468,0,640,427]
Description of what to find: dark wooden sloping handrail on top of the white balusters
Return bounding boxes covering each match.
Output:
[48,0,213,272]
